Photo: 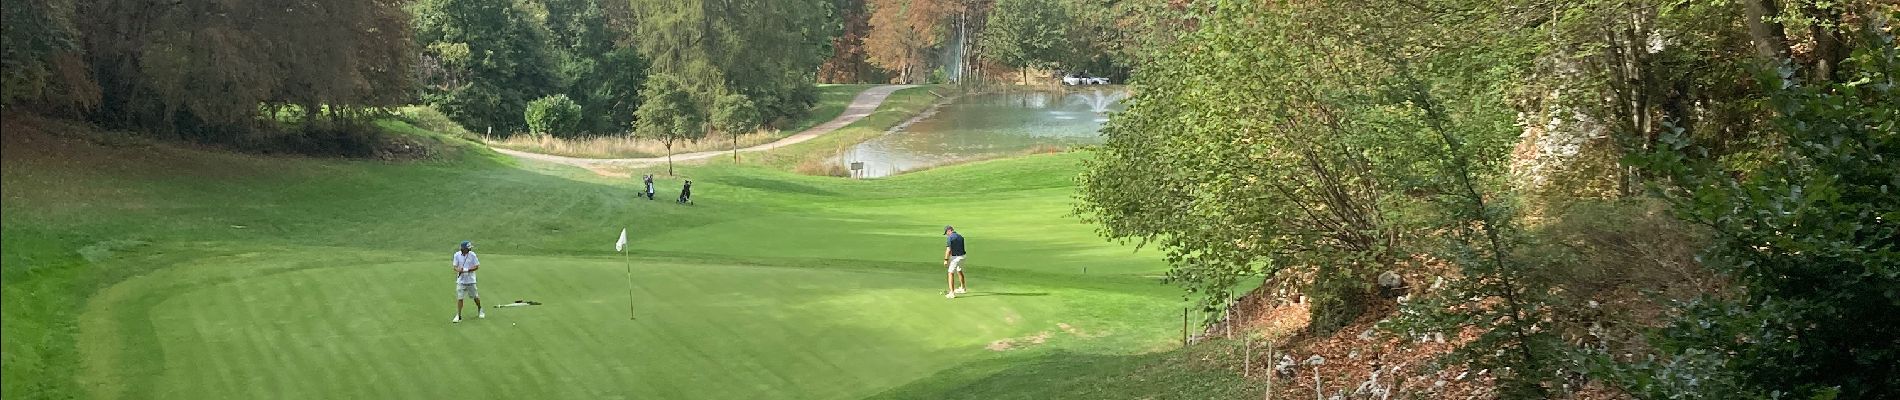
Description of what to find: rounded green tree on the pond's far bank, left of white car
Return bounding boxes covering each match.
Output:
[982,0,1075,83]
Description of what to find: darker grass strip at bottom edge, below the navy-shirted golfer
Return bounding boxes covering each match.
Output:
[870,345,1264,400]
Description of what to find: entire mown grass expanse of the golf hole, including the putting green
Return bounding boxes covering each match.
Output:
[4,118,1180,398]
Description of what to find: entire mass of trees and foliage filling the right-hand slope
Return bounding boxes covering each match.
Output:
[1079,0,1900,398]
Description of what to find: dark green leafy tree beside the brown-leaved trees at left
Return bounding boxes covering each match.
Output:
[409,0,559,133]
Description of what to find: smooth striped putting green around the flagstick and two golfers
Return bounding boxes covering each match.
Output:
[82,254,1140,398]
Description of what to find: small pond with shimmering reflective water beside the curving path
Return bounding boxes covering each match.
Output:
[838,87,1129,176]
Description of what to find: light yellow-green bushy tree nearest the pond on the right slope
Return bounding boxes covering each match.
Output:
[1077,6,1433,334]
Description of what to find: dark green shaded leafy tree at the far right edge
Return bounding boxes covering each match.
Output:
[1617,24,1900,398]
